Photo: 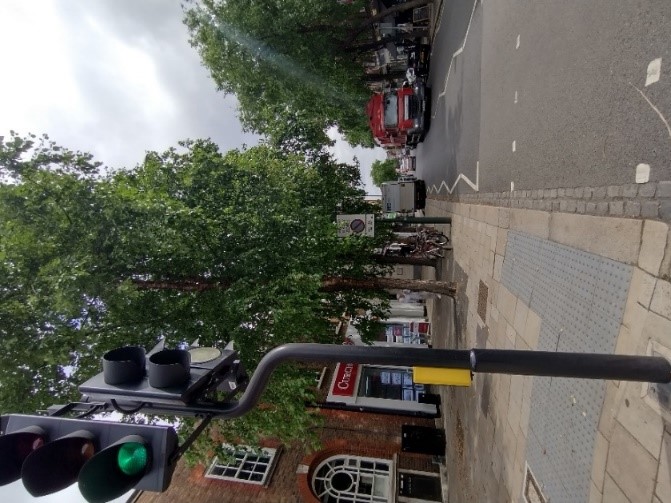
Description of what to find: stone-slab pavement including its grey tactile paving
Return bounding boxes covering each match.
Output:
[423,197,671,503]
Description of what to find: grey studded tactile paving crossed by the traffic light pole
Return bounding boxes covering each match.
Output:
[501,231,632,503]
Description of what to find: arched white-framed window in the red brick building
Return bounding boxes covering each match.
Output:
[312,456,391,503]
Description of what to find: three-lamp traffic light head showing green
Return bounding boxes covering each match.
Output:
[0,414,178,503]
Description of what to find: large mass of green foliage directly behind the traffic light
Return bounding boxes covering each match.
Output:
[0,135,394,448]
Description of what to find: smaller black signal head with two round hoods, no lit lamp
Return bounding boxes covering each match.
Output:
[79,344,240,414]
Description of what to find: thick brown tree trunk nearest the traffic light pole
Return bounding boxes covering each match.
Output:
[320,276,457,297]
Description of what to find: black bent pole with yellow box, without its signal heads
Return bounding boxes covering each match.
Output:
[80,344,671,419]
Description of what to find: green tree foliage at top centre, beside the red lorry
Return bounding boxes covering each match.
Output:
[185,0,373,150]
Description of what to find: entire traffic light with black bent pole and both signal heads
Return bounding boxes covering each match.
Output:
[5,344,671,503]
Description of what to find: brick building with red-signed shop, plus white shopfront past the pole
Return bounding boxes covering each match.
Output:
[133,302,445,503]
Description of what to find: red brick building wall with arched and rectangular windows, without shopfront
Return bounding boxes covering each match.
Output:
[134,409,442,503]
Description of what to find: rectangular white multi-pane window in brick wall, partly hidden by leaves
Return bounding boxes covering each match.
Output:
[205,444,277,485]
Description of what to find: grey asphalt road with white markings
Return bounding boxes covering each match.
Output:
[417,0,671,194]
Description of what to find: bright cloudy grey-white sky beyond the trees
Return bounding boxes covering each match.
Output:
[0,0,384,193]
